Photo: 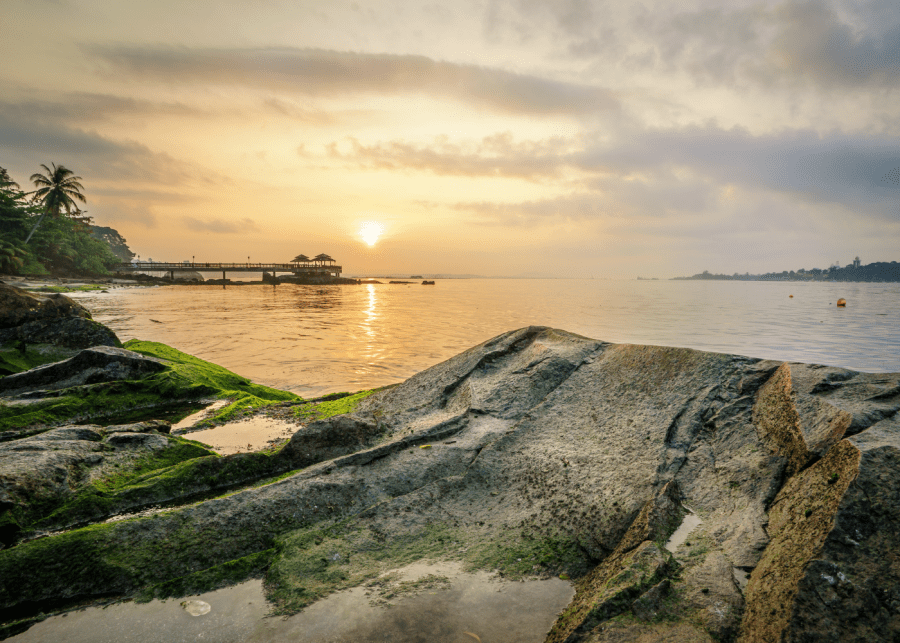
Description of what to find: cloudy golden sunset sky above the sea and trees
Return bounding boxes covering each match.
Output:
[0,0,900,278]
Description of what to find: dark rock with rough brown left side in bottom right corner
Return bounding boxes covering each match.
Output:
[738,416,900,643]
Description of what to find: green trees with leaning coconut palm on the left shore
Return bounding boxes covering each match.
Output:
[0,163,134,276]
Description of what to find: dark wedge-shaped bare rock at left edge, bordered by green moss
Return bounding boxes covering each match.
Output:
[0,346,166,395]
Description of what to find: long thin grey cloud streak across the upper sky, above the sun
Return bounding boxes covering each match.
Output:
[87,47,619,114]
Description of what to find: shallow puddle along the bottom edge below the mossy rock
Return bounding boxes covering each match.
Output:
[9,563,574,643]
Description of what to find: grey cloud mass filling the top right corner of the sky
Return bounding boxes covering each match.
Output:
[500,0,900,90]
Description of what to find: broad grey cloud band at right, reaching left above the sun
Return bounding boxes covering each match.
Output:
[320,125,900,222]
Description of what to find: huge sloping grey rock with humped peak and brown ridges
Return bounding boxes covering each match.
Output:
[0,327,900,643]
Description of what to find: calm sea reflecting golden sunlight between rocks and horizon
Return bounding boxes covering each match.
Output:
[78,279,900,397]
